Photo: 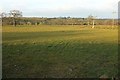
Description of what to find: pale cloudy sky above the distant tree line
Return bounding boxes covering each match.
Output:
[0,0,119,18]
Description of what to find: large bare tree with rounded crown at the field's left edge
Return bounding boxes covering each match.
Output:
[9,10,22,26]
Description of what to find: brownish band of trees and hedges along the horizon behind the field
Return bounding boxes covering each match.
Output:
[0,10,118,26]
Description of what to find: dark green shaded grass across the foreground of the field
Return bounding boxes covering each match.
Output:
[3,42,118,78]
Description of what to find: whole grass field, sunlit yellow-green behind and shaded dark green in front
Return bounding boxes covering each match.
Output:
[2,25,118,78]
